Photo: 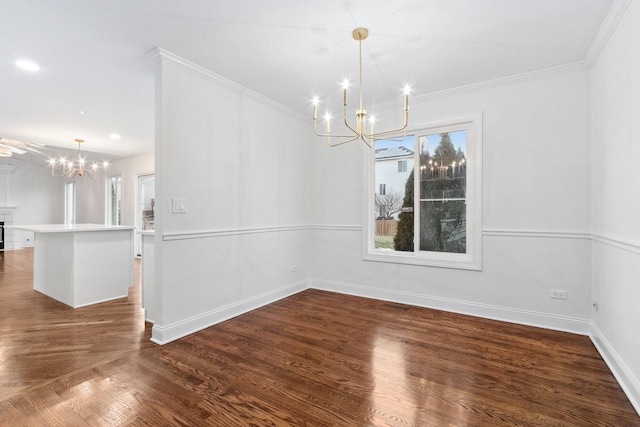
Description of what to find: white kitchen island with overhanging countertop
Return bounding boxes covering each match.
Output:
[13,224,135,308]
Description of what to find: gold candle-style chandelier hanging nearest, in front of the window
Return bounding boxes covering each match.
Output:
[313,28,410,148]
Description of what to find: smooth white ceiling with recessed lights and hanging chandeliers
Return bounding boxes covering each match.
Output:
[0,0,620,160]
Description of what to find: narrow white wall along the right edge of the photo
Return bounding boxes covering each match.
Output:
[591,2,640,412]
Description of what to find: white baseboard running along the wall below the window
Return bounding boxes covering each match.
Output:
[310,279,591,335]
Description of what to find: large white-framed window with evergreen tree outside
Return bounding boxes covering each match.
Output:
[363,115,482,270]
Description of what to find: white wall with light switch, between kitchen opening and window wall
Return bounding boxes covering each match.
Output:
[152,51,309,343]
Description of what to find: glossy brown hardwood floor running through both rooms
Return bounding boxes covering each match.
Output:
[0,250,640,426]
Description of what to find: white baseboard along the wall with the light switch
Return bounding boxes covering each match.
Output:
[151,280,309,345]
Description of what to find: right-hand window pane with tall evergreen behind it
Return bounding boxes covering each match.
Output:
[419,131,467,253]
